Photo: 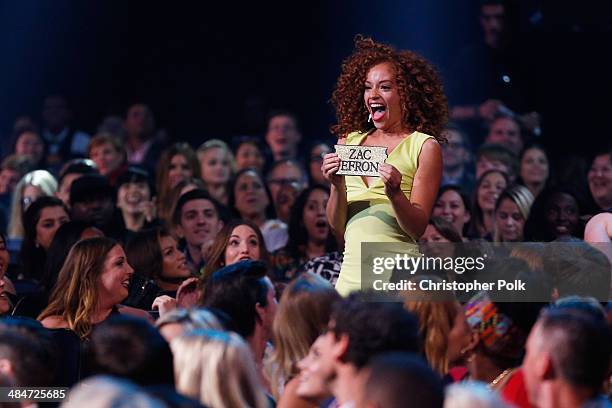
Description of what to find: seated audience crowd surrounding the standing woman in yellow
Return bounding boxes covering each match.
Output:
[0,89,612,408]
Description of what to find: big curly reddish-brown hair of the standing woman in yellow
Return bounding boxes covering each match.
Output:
[330,35,448,142]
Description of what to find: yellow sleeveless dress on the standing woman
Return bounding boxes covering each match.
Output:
[336,129,435,296]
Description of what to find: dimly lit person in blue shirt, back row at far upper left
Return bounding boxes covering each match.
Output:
[42,95,90,169]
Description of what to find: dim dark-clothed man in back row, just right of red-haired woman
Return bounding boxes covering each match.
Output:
[124,103,163,174]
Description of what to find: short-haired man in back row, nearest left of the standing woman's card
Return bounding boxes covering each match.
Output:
[266,111,302,161]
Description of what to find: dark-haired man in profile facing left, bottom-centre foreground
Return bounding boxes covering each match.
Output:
[297,293,419,406]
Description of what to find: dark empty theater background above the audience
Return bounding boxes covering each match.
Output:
[0,0,612,159]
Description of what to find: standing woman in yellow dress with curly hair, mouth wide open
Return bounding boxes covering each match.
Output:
[321,36,448,295]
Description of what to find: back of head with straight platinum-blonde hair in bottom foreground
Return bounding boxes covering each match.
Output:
[171,329,268,408]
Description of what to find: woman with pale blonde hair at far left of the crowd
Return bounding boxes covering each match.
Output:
[8,170,57,240]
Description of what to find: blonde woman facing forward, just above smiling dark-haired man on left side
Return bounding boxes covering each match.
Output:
[198,139,236,205]
